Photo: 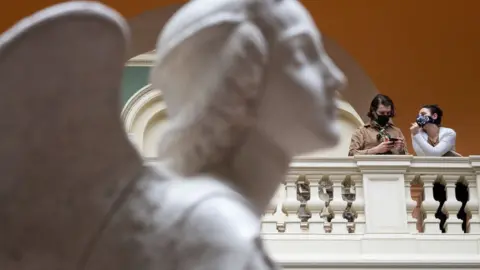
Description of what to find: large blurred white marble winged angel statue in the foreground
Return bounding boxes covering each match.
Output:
[0,0,344,270]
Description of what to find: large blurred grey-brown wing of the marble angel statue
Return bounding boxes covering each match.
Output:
[0,2,143,270]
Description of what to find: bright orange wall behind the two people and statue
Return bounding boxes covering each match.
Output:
[0,0,480,155]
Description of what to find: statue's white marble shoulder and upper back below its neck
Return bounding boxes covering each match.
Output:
[87,169,260,270]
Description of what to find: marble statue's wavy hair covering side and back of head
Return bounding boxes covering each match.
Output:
[152,19,267,176]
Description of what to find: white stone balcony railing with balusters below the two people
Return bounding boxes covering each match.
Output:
[147,156,480,269]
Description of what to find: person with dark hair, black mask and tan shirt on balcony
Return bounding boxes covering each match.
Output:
[348,94,408,156]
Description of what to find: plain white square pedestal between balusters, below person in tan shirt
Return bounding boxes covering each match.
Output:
[355,155,412,234]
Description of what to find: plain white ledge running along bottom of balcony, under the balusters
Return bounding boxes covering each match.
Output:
[262,233,480,269]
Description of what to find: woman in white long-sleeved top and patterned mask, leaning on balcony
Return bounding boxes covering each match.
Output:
[410,105,460,157]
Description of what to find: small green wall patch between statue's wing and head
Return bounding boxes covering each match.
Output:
[122,67,150,106]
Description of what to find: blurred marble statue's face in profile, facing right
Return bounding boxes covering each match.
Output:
[261,0,346,155]
